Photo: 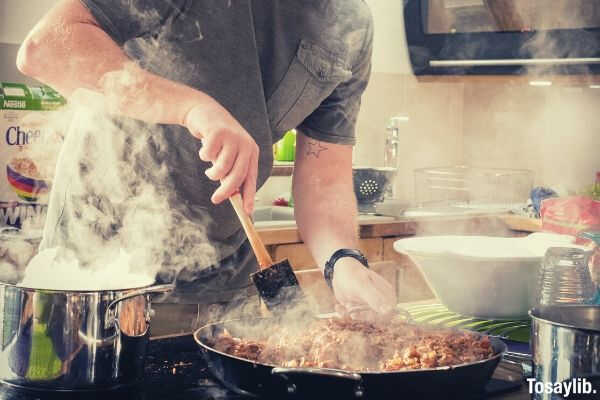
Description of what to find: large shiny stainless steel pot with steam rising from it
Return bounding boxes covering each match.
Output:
[0,283,173,391]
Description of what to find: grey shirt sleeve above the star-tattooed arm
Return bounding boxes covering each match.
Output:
[298,19,373,145]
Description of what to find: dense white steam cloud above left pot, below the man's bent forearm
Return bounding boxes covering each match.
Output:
[19,91,217,289]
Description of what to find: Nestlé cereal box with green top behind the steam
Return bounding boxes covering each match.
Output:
[0,82,66,228]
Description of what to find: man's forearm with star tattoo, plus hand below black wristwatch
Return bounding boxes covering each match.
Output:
[293,132,396,318]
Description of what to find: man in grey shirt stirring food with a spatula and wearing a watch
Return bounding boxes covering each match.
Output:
[17,0,395,324]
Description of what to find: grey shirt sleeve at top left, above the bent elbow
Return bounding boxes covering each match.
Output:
[80,0,185,45]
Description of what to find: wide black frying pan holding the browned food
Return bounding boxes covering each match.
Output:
[194,317,506,399]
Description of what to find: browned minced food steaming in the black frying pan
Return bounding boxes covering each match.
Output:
[211,318,494,372]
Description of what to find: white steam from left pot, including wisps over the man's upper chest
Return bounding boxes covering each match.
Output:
[21,2,225,290]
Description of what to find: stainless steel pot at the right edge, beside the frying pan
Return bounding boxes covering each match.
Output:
[529,305,600,400]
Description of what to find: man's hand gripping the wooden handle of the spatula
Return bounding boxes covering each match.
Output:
[184,101,259,214]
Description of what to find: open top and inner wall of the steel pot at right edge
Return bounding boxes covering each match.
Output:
[529,304,600,332]
